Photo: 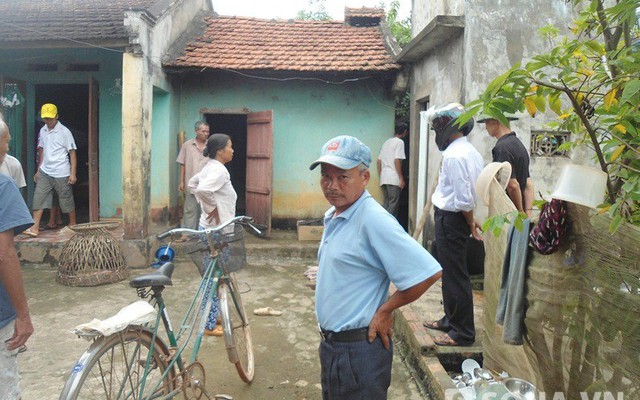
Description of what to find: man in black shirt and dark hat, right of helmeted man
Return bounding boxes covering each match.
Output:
[478,116,534,218]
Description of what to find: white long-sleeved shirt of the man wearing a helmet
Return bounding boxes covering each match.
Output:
[431,136,484,212]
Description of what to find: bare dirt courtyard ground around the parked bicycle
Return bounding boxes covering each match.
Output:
[18,260,425,400]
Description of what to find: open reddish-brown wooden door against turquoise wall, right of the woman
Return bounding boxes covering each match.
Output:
[246,110,273,237]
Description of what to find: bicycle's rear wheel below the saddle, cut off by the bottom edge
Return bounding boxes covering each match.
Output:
[60,326,175,400]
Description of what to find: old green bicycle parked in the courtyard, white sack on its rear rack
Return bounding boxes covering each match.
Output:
[60,216,260,399]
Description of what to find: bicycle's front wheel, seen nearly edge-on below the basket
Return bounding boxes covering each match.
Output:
[218,278,254,383]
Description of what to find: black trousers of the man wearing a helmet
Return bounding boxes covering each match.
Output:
[434,208,476,344]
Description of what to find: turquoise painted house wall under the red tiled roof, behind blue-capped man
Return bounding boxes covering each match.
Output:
[179,69,394,219]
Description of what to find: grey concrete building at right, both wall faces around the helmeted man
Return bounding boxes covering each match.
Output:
[410,0,588,236]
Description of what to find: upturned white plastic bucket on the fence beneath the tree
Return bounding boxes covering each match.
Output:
[550,164,607,208]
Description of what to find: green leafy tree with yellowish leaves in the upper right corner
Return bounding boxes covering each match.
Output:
[461,0,640,231]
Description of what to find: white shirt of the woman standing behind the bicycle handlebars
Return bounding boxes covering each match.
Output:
[188,159,238,228]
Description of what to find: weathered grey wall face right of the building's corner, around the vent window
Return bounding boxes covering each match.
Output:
[465,0,573,205]
